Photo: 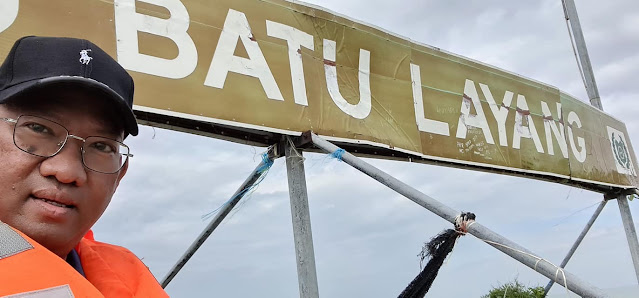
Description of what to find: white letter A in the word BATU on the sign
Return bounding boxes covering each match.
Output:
[204,9,284,100]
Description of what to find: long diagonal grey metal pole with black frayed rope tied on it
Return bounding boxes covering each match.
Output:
[312,134,605,297]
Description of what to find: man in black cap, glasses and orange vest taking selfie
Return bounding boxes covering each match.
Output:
[0,36,167,297]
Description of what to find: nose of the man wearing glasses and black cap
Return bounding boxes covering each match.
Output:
[40,138,87,186]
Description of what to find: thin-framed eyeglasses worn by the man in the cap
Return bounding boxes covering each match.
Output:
[0,115,133,174]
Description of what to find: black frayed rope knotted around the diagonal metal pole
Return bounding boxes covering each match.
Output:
[398,212,475,298]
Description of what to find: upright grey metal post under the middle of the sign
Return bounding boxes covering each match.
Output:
[284,137,319,298]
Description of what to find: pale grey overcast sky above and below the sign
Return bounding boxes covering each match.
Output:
[94,0,639,298]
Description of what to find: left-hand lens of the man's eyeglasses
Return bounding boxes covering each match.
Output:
[13,116,68,157]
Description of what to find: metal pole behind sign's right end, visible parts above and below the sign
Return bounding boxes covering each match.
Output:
[563,0,639,282]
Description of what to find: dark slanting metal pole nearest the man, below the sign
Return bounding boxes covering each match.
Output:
[161,149,273,288]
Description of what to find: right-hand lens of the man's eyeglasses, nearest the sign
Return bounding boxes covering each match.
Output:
[82,137,129,174]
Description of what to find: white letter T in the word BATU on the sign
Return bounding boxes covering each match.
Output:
[266,20,315,106]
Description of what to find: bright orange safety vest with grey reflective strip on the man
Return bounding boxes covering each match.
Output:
[0,222,168,298]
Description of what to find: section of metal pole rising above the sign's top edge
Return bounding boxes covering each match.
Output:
[563,0,603,110]
